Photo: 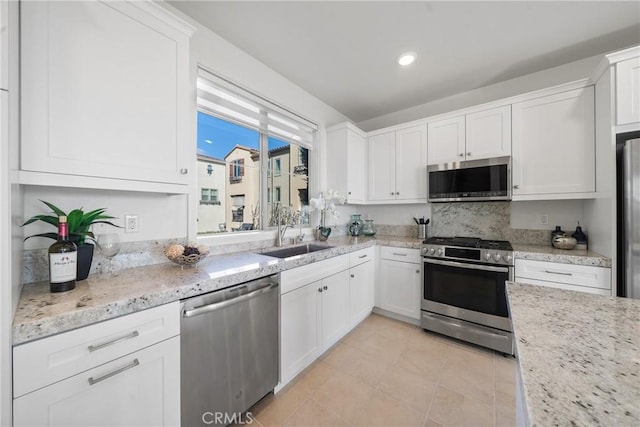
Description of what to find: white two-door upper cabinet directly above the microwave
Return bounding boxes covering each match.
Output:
[428,105,511,165]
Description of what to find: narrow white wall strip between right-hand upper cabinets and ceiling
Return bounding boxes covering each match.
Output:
[357,55,603,131]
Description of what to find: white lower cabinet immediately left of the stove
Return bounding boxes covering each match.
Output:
[380,246,422,320]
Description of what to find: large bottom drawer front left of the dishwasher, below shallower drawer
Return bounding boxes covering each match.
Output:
[13,337,180,427]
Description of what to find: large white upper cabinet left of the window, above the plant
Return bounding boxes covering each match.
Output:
[21,0,195,191]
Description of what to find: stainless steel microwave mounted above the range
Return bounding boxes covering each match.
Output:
[427,156,511,202]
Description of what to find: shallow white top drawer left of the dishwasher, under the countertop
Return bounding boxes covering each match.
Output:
[13,301,180,397]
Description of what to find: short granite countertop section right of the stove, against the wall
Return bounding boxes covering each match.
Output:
[512,244,611,268]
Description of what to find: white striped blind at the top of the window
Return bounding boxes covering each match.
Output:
[197,68,318,149]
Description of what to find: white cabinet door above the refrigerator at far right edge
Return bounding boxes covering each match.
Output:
[616,58,640,125]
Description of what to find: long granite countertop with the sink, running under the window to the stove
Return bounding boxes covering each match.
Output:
[13,236,421,345]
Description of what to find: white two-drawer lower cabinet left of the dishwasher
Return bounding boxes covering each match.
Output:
[13,302,180,427]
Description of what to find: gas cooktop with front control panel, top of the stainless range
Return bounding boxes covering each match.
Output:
[421,237,513,265]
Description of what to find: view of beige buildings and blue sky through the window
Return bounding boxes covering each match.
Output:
[197,112,309,234]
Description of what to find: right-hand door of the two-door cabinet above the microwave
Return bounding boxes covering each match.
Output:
[465,105,511,160]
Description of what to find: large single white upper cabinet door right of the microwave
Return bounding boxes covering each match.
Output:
[512,86,595,199]
